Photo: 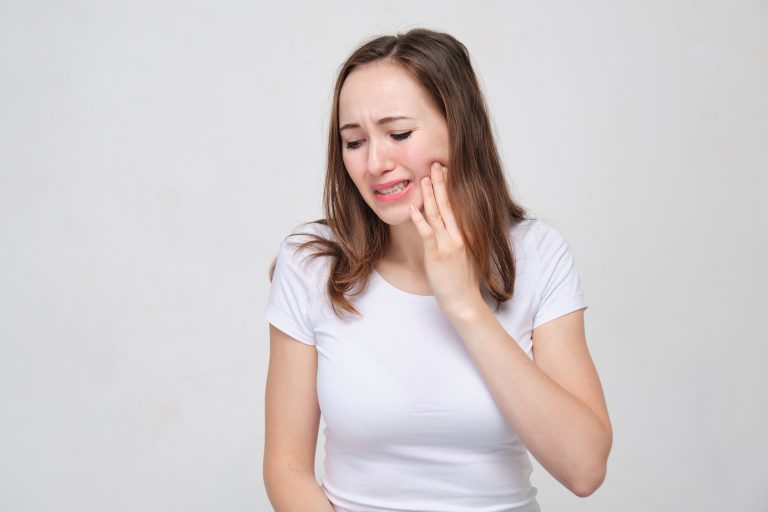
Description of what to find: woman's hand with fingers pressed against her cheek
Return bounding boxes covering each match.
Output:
[411,162,487,316]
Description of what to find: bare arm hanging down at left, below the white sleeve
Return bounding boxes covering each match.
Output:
[263,324,334,512]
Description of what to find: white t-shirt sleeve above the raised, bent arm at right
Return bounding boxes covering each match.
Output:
[533,223,587,329]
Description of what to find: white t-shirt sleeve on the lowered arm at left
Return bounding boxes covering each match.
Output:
[264,237,317,345]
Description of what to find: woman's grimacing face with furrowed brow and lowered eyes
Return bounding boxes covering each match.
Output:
[339,61,450,225]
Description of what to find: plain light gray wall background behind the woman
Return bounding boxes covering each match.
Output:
[0,0,768,512]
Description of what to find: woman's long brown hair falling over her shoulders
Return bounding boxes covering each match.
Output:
[269,28,526,316]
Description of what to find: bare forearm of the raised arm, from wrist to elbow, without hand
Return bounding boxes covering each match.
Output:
[451,307,611,496]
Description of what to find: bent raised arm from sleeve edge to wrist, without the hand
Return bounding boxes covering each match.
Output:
[448,302,613,497]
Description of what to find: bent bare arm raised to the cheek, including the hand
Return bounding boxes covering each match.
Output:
[411,166,613,496]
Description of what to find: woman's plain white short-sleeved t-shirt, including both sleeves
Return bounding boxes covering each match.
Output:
[264,219,587,512]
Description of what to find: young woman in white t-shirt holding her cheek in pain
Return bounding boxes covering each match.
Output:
[264,29,612,512]
